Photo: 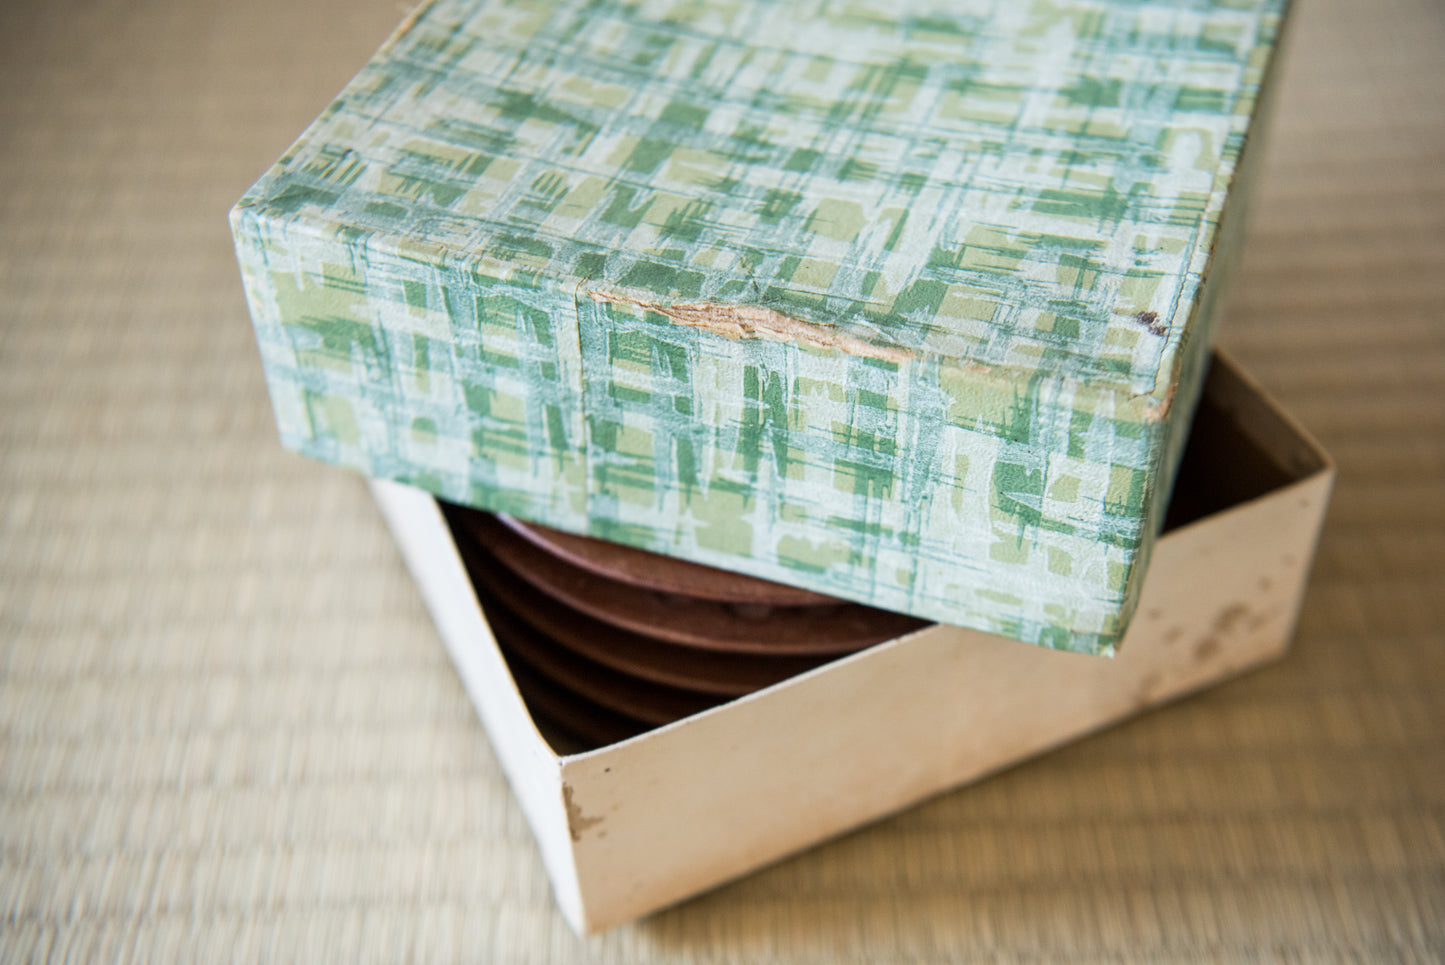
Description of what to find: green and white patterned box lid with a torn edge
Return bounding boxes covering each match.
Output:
[231,0,1283,653]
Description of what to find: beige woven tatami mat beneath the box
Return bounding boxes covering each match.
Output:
[0,0,1445,962]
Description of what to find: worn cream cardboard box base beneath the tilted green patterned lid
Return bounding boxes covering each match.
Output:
[373,357,1334,932]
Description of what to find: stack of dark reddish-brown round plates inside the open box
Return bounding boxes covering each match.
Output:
[447,506,925,747]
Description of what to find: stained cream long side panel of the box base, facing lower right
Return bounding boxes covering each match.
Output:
[562,462,1331,930]
